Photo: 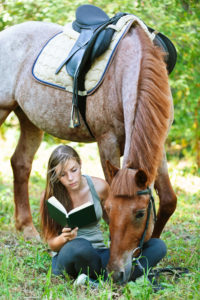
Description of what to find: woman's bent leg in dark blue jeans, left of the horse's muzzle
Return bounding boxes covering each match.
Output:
[52,238,107,279]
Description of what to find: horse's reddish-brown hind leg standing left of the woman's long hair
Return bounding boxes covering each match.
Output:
[11,108,43,239]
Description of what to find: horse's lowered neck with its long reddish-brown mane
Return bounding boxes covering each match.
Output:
[118,27,171,184]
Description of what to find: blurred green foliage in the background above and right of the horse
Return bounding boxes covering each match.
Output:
[0,0,200,166]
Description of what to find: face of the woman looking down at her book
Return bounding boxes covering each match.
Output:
[56,159,82,192]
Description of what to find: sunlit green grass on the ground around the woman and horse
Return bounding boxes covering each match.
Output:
[0,133,200,300]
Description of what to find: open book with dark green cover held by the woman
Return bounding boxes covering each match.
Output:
[47,196,97,228]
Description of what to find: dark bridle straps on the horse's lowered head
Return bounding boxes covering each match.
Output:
[132,187,156,260]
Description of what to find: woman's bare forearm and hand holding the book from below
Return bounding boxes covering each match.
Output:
[47,227,78,252]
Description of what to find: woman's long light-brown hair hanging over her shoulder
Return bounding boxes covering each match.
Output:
[40,145,81,240]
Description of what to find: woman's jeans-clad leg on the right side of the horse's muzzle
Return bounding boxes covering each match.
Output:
[130,238,167,281]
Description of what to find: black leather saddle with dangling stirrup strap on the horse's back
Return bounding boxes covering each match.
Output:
[56,4,126,134]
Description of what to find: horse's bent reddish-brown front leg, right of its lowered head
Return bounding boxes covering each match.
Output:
[152,153,177,237]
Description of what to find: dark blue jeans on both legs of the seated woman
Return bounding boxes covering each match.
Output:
[52,238,167,281]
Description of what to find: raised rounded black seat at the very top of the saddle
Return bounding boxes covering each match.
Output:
[72,4,109,32]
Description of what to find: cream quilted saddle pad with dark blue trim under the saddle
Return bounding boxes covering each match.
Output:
[32,15,151,95]
